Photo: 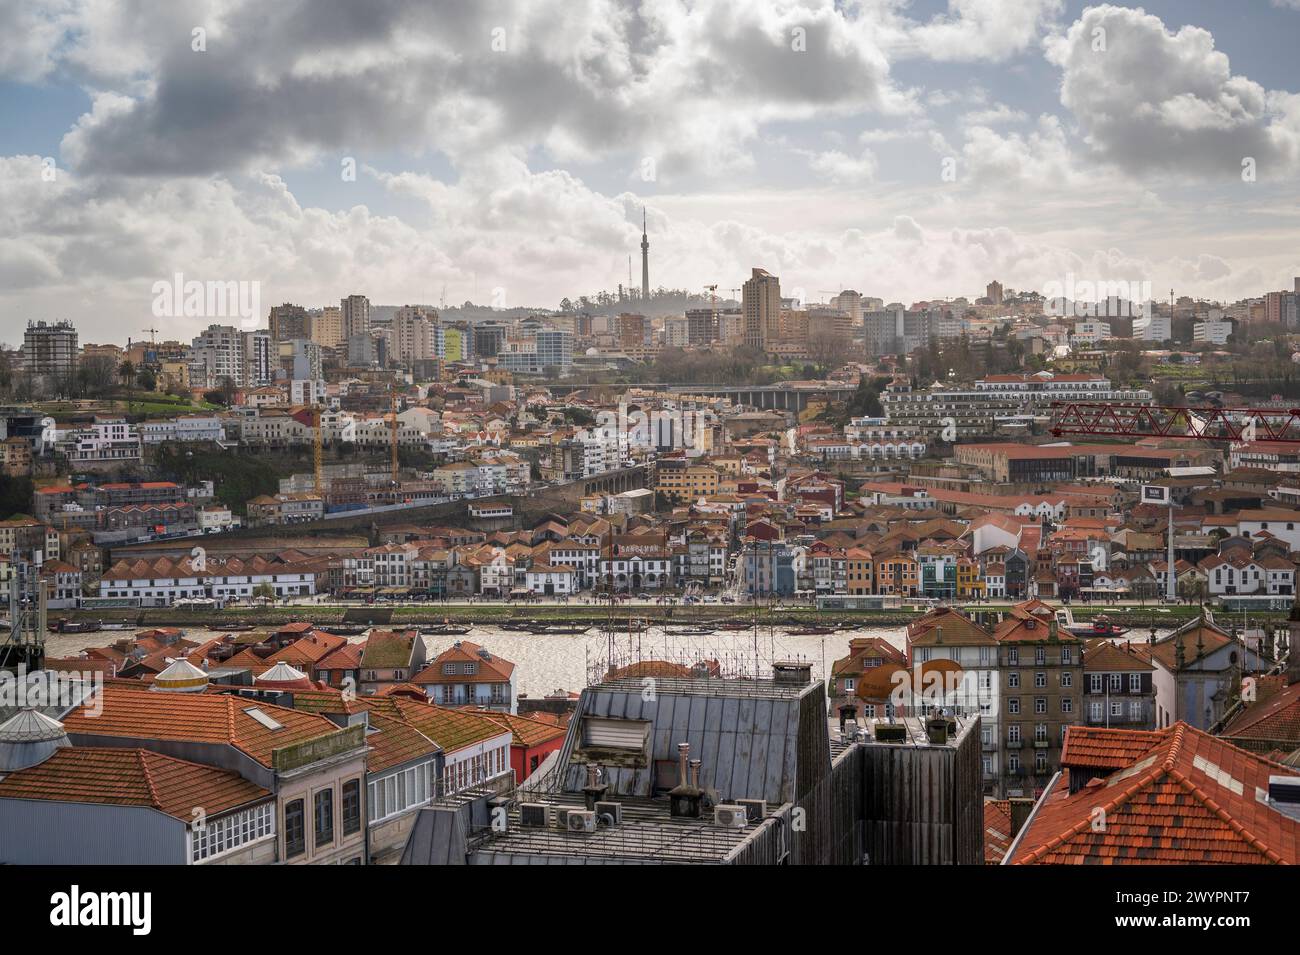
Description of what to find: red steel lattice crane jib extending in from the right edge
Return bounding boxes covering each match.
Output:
[1052,401,1300,442]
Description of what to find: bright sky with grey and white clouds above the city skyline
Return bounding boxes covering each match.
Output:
[0,0,1300,344]
